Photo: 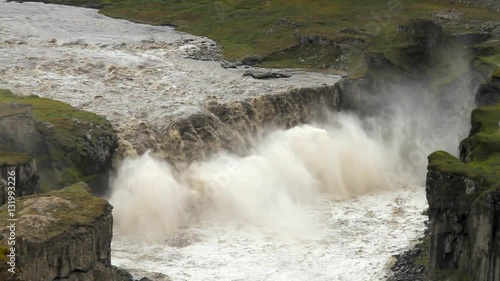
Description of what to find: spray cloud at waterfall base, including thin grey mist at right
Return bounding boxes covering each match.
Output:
[110,79,471,238]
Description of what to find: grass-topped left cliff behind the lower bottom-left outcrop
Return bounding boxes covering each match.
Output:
[0,89,117,190]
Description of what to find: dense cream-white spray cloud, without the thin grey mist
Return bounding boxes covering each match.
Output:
[110,115,393,237]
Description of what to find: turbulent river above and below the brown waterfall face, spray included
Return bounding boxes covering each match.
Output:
[0,1,472,281]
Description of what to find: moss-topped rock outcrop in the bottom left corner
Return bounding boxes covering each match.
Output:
[0,183,132,281]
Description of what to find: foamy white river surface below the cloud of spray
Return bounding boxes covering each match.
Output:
[113,187,426,281]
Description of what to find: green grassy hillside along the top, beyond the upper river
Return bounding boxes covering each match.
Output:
[23,0,500,75]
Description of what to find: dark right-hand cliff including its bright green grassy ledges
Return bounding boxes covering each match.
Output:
[426,100,500,281]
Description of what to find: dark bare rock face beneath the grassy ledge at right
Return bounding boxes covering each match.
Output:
[427,167,500,281]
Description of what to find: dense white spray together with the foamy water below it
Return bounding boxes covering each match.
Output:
[106,114,434,280]
